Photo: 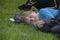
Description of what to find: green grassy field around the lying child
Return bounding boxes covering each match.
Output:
[0,0,59,40]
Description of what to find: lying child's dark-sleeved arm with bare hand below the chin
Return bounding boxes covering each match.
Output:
[36,19,57,28]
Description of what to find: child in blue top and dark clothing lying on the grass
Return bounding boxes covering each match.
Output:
[10,7,60,35]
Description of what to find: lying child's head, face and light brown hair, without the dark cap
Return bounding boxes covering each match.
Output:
[20,11,39,23]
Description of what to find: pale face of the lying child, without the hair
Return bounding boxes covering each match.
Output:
[26,12,39,23]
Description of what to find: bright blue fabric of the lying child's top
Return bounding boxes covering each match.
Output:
[39,8,59,19]
